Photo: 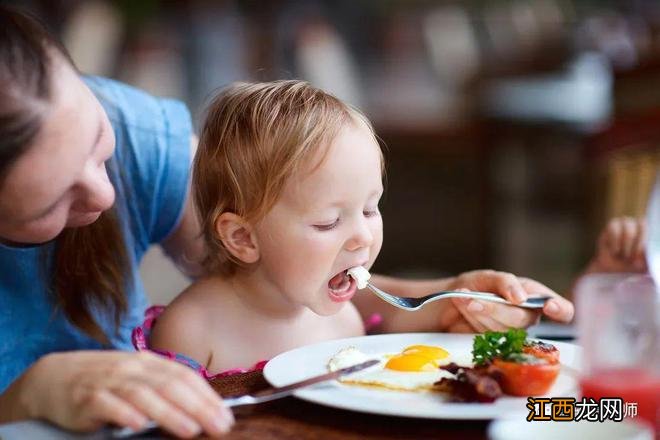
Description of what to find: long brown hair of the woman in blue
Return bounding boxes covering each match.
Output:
[0,6,130,345]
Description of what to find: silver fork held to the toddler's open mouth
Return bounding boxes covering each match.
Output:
[367,283,551,312]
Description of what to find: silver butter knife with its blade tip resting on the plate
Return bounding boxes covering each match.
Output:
[112,359,380,438]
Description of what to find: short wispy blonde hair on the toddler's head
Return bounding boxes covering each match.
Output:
[192,81,382,275]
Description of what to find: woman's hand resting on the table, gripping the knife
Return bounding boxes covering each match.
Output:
[0,351,234,437]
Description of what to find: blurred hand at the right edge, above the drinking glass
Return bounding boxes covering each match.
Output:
[583,217,647,274]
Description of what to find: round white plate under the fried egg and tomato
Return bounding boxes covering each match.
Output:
[264,333,580,419]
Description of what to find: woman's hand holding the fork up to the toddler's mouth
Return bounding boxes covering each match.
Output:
[445,270,574,332]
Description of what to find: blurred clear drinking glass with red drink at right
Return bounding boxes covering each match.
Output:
[576,274,660,433]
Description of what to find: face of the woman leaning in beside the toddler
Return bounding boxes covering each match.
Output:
[0,57,115,244]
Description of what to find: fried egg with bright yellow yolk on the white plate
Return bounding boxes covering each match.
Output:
[328,345,454,391]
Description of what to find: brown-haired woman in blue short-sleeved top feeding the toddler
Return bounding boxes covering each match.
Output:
[0,8,573,437]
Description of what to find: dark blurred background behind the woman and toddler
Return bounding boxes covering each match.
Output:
[4,0,660,304]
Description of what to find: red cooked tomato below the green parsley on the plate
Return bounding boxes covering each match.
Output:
[493,359,561,397]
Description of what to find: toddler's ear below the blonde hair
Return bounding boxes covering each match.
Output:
[215,212,259,264]
